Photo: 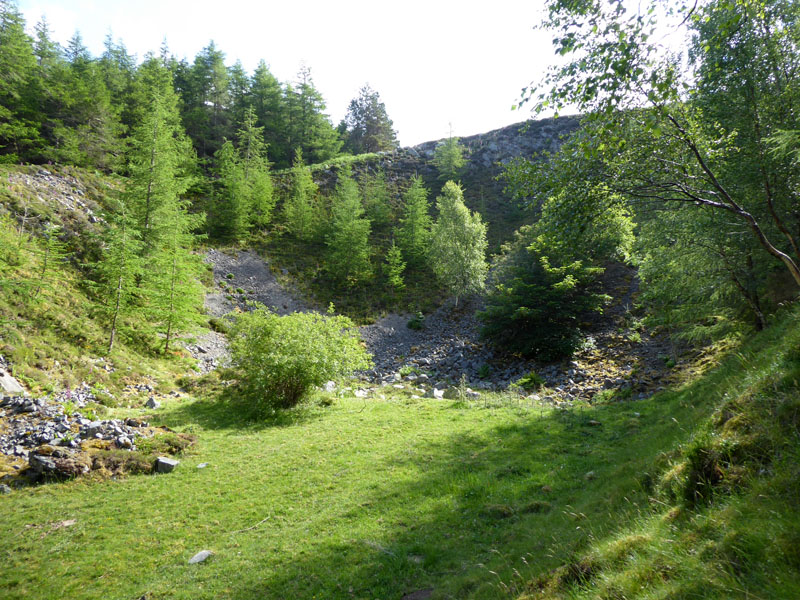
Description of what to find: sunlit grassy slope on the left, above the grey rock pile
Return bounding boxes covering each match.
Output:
[0,167,203,394]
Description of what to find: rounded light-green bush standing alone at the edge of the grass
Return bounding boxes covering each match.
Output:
[231,307,371,413]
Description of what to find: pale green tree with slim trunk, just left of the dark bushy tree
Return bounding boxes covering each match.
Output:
[428,181,488,306]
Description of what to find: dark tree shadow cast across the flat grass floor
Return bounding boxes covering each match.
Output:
[214,392,708,600]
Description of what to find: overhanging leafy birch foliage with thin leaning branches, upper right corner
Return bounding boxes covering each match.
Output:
[524,0,800,326]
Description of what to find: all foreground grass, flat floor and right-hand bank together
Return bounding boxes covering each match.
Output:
[0,304,800,600]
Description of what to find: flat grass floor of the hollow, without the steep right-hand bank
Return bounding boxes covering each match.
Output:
[0,378,706,599]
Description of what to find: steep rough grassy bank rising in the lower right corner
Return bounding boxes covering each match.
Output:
[518,307,800,599]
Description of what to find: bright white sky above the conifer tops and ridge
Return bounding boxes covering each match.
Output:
[18,0,554,146]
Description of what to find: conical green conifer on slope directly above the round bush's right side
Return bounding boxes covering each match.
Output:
[326,168,372,286]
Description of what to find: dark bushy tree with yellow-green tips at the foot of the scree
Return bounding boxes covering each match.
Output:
[479,182,633,360]
